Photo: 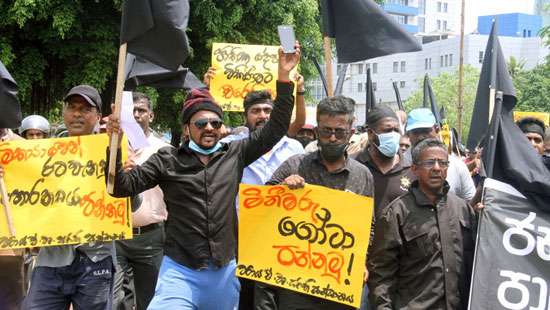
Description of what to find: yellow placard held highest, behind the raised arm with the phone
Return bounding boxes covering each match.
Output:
[210,43,294,112]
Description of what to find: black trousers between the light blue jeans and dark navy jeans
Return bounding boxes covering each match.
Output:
[113,225,165,310]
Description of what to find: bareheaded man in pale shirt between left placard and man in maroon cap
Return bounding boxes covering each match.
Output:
[113,92,172,310]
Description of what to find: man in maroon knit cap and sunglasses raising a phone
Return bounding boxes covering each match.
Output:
[106,45,300,310]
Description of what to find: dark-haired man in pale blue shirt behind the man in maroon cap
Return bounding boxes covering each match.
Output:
[221,88,304,310]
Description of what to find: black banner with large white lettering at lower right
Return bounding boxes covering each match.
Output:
[469,179,550,309]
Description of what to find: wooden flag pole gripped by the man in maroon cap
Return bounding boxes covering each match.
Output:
[107,43,127,194]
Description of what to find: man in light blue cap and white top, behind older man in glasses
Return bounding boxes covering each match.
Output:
[405,108,476,200]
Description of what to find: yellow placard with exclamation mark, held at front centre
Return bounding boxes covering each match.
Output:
[237,184,374,307]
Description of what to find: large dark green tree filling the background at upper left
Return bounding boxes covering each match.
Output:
[0,0,322,135]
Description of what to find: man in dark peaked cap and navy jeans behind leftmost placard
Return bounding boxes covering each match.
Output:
[24,85,114,310]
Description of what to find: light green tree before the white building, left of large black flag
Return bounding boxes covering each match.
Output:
[405,65,479,143]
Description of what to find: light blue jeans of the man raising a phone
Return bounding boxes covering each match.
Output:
[147,256,241,310]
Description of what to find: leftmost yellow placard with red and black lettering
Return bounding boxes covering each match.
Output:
[0,134,132,249]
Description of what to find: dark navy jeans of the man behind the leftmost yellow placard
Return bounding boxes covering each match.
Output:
[24,254,114,310]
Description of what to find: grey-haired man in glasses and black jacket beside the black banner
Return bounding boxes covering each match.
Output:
[368,139,476,310]
